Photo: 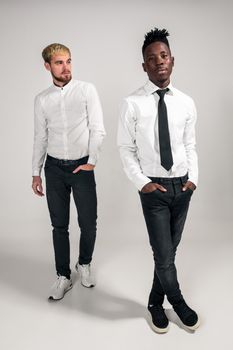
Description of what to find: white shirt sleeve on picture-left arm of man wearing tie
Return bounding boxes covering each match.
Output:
[117,100,151,191]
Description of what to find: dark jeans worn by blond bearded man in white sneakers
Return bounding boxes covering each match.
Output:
[45,156,97,278]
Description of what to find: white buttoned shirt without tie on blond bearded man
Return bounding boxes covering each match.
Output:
[32,79,105,176]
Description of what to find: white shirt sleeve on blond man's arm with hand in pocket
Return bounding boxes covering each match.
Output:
[87,84,106,165]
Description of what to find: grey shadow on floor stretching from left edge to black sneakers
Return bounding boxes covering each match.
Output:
[0,247,146,320]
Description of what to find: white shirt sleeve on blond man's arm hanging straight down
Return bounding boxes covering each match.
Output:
[32,96,48,176]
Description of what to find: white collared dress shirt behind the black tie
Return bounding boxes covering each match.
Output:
[118,81,198,190]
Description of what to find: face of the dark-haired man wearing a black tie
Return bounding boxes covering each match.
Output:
[142,41,174,88]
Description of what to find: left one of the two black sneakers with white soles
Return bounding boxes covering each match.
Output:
[148,305,169,333]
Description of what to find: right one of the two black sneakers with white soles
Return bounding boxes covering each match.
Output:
[173,300,200,331]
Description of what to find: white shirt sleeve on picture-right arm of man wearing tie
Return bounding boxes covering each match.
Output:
[184,100,198,186]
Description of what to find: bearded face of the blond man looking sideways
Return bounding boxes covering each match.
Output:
[45,51,72,86]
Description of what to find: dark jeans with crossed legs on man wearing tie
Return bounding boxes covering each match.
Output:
[139,175,193,305]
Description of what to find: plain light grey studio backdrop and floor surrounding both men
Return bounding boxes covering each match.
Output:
[0,0,233,350]
